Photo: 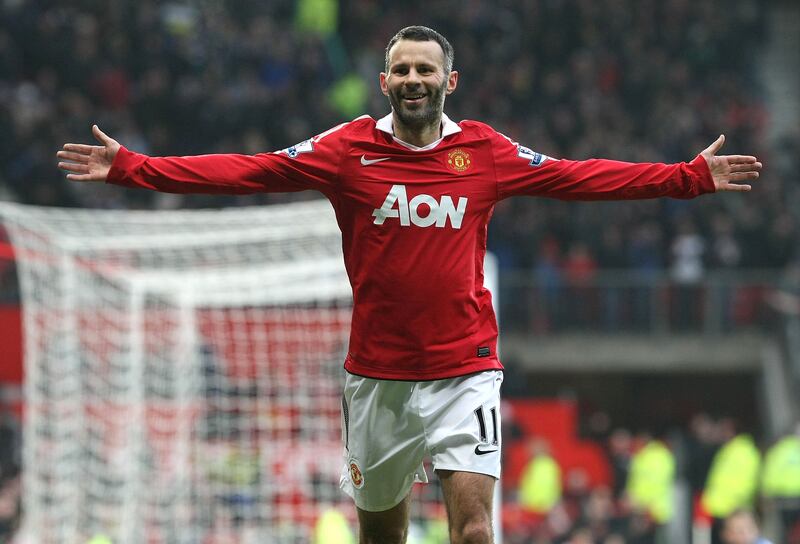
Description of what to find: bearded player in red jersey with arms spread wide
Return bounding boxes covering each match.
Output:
[58,26,761,544]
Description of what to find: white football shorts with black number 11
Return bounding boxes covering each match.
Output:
[340,370,503,512]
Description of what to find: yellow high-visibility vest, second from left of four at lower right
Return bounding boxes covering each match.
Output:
[626,440,675,523]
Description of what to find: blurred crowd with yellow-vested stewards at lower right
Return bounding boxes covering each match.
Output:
[503,412,800,544]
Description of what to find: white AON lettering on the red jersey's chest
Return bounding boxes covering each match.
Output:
[372,185,467,229]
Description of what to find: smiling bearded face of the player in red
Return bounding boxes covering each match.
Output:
[380,40,458,128]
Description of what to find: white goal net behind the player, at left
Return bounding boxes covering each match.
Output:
[0,201,500,544]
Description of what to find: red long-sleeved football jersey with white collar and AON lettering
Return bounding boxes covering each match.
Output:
[108,115,715,380]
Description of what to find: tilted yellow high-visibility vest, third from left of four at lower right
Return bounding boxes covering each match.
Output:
[701,434,761,518]
